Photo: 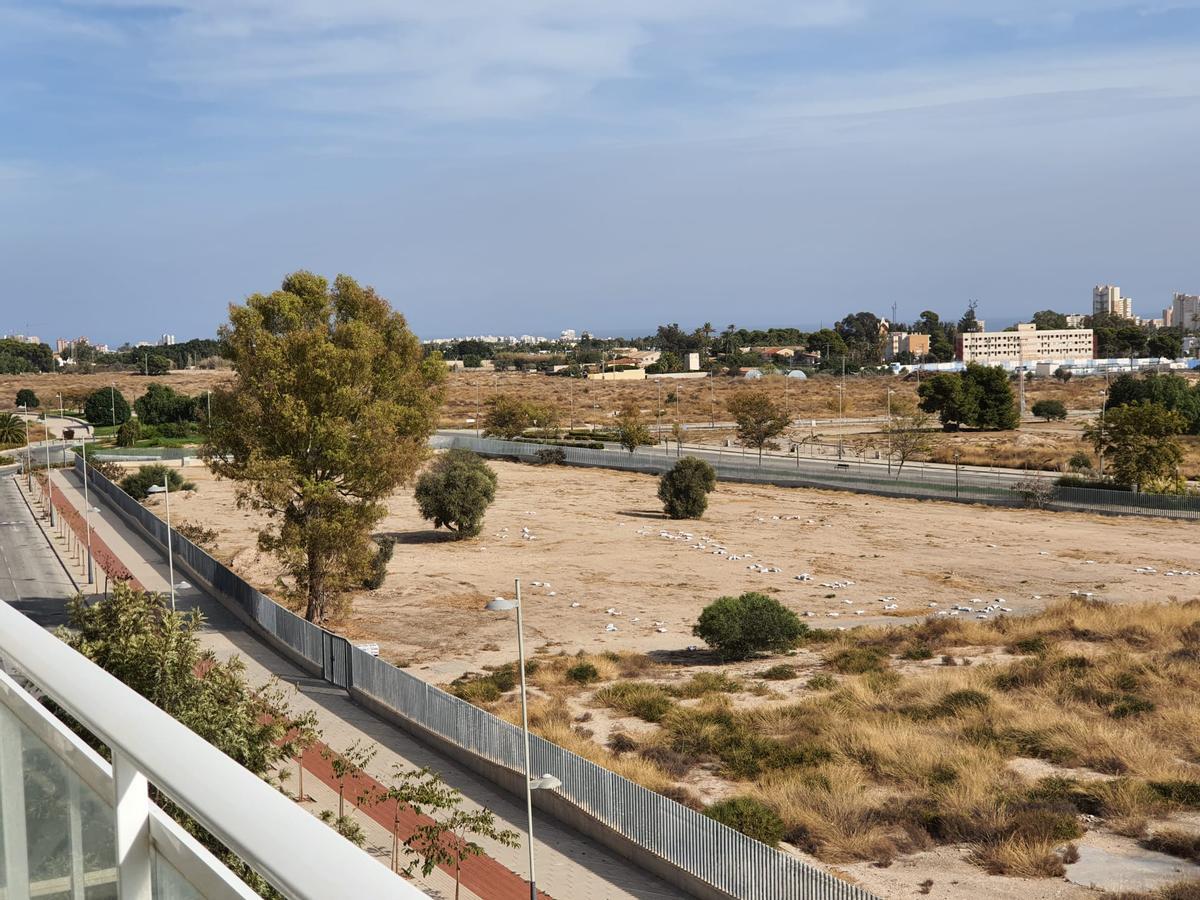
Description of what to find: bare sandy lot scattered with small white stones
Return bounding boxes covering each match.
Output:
[151,453,1200,682]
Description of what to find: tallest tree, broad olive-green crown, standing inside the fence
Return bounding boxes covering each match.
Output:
[202,271,445,622]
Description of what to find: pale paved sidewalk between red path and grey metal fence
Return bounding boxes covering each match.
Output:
[44,470,686,900]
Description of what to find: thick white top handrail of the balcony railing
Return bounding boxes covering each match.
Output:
[0,601,426,900]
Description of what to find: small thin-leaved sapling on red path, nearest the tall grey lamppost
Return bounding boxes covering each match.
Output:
[404,779,520,900]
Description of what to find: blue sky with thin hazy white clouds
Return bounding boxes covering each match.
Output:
[0,0,1200,341]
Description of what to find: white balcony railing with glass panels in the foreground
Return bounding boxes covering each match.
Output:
[0,601,426,900]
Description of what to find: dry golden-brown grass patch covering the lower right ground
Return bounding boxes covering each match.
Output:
[456,600,1200,877]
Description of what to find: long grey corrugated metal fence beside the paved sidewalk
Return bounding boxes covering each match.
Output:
[76,458,872,900]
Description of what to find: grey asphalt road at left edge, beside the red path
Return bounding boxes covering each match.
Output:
[0,478,76,628]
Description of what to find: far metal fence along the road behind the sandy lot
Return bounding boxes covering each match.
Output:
[432,434,1200,520]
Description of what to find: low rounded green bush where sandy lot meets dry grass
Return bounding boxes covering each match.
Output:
[691,592,809,661]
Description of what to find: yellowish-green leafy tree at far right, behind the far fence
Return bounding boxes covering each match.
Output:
[1084,400,1187,491]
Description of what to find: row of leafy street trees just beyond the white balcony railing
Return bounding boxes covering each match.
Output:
[59,582,518,898]
